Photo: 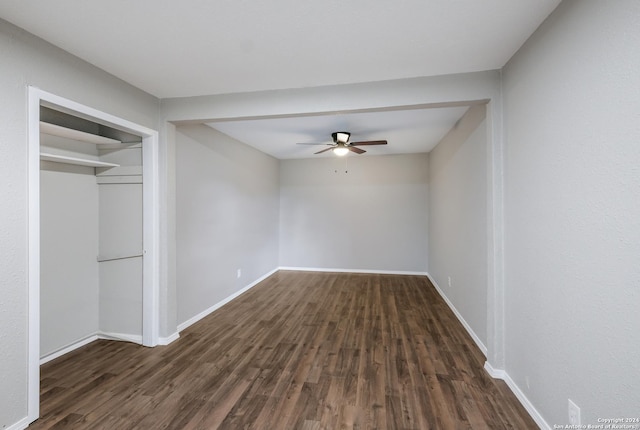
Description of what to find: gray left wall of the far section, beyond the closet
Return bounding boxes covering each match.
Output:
[176,125,279,324]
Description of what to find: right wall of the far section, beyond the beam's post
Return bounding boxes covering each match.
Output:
[429,105,488,352]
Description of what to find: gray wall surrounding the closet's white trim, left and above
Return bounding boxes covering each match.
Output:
[0,20,158,427]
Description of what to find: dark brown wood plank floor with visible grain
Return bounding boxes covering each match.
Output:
[30,271,537,430]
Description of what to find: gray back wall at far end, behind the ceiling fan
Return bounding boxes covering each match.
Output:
[280,154,428,272]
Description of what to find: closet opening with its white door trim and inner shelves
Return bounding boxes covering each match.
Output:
[28,88,160,422]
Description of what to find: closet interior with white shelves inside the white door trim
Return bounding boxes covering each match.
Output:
[40,107,144,361]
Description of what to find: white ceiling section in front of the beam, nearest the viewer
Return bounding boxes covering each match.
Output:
[0,0,560,98]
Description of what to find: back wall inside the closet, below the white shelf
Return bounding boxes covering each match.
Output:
[40,162,99,357]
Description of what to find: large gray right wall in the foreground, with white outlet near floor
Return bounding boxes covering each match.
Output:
[504,0,640,426]
